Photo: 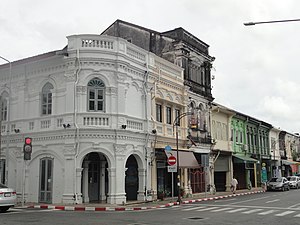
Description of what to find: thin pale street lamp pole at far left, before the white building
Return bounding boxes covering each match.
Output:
[0,56,12,185]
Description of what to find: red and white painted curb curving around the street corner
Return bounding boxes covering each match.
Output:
[28,191,264,211]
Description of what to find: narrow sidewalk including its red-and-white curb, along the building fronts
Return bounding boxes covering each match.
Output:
[15,188,264,211]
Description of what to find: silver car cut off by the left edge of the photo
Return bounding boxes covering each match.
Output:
[0,184,17,212]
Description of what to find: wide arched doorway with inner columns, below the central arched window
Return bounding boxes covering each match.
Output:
[81,152,108,202]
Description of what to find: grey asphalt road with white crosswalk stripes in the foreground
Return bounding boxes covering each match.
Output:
[0,190,300,225]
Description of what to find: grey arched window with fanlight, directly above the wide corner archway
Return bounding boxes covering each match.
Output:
[88,78,105,111]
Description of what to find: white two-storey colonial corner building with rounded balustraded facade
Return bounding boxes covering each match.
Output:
[0,35,185,204]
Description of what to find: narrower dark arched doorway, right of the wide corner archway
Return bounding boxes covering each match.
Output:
[125,155,139,201]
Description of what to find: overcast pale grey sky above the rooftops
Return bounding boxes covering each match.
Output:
[0,0,300,133]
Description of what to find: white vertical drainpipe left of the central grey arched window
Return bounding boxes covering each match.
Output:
[73,48,81,204]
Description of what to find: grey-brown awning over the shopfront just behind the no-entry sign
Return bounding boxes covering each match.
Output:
[166,151,200,168]
